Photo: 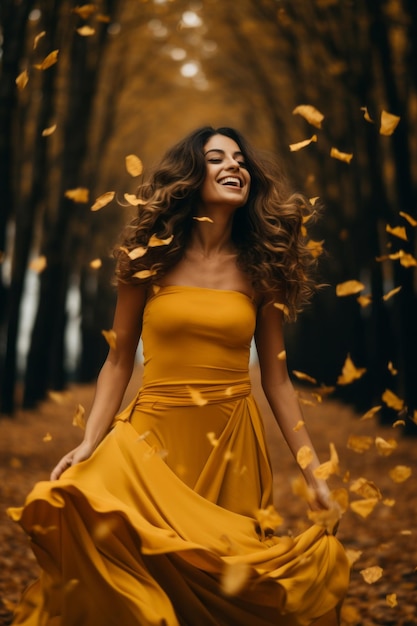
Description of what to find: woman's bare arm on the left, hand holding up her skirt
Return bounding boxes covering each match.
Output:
[51,283,146,480]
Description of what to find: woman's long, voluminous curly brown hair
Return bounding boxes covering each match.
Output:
[114,126,317,320]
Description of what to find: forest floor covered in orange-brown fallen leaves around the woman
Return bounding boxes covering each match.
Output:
[0,367,417,626]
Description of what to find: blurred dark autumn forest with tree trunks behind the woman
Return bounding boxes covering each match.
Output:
[0,0,417,434]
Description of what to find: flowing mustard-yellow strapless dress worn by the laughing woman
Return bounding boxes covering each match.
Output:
[9,286,349,626]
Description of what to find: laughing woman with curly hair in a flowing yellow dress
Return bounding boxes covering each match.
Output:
[10,127,348,626]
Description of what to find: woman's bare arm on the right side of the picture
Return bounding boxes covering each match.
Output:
[255,303,330,508]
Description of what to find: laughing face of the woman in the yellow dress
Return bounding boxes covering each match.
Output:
[200,135,251,209]
